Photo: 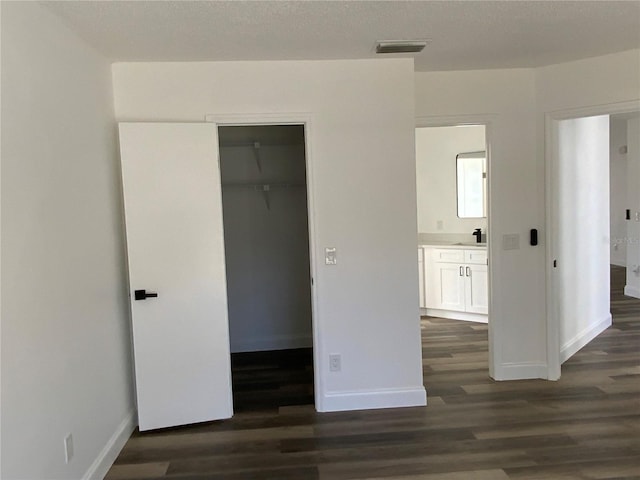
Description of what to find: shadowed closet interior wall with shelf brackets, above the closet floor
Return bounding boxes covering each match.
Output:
[219,126,312,352]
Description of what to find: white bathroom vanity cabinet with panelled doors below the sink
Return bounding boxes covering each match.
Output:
[423,247,488,321]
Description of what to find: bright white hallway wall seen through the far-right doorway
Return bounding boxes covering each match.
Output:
[554,115,611,362]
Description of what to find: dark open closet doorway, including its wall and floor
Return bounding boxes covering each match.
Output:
[218,125,314,413]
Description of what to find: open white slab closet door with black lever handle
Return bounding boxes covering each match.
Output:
[120,123,233,430]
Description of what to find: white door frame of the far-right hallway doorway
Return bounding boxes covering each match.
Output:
[544,100,640,380]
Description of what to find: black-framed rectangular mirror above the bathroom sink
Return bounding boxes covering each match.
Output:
[456,152,487,218]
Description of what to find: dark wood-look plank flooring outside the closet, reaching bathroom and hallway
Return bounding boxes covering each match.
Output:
[107,268,640,480]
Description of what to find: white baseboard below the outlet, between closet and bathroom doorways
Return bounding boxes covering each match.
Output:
[322,386,427,412]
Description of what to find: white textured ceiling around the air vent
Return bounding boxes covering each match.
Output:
[41,0,640,71]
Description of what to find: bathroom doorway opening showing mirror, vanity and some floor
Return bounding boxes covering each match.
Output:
[416,124,489,377]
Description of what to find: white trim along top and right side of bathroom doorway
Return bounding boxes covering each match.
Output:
[414,114,502,378]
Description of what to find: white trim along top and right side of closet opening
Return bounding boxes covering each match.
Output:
[205,113,324,412]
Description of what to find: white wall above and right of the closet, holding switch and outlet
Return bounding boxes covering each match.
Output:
[113,59,425,410]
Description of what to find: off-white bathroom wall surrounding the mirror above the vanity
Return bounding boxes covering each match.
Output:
[416,125,487,235]
